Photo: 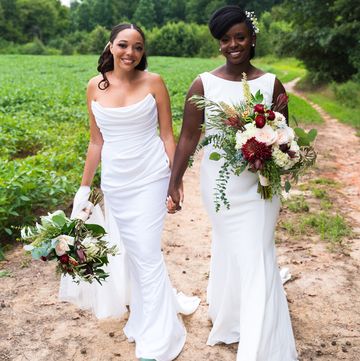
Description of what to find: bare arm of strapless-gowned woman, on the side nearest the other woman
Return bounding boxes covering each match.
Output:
[153,75,176,168]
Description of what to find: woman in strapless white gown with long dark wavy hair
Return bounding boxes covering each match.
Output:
[60,24,199,361]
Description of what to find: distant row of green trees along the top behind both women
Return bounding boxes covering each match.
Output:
[0,0,281,42]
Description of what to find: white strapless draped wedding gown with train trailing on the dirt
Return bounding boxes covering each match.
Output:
[60,94,200,361]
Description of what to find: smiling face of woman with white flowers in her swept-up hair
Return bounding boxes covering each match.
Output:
[220,22,256,64]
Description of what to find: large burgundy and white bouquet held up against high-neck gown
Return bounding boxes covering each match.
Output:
[190,74,317,211]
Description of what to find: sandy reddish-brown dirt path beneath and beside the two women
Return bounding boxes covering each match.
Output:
[0,85,360,361]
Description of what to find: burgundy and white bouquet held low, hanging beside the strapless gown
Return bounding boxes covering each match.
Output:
[21,192,118,284]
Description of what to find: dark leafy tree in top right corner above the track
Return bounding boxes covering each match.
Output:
[286,0,360,82]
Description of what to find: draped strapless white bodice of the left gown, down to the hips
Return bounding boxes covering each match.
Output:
[91,93,170,192]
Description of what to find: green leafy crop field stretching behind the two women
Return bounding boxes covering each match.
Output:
[0,55,320,240]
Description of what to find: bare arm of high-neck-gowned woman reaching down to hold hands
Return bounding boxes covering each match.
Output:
[168,78,204,206]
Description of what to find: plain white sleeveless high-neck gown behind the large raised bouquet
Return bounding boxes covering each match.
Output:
[200,73,297,361]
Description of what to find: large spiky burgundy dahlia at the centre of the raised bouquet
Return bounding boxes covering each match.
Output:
[241,137,271,171]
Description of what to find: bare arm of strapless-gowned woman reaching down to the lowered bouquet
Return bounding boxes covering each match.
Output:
[81,78,104,186]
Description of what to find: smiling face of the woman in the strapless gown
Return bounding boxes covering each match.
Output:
[110,29,144,71]
